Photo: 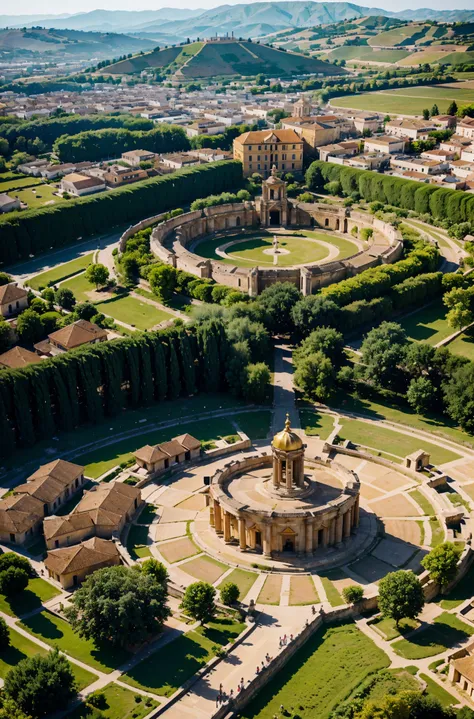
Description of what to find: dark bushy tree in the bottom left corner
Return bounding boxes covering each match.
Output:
[4,649,77,717]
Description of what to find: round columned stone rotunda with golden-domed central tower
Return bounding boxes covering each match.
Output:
[209,415,360,557]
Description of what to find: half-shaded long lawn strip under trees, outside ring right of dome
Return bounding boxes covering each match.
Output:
[333,393,474,449]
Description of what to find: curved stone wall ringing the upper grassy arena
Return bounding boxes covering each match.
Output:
[151,198,403,296]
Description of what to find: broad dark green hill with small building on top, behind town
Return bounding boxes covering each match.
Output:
[106,39,346,79]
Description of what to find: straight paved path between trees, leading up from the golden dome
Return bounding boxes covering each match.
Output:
[272,343,300,434]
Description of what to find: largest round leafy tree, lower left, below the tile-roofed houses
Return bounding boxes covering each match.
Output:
[66,566,170,646]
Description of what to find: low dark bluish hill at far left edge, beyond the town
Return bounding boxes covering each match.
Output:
[0,27,157,60]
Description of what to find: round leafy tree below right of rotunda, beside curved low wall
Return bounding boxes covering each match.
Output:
[379,569,425,627]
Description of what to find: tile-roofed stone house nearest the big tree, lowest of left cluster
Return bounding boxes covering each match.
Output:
[44,537,121,589]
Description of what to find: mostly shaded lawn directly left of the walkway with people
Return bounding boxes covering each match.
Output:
[121,618,245,697]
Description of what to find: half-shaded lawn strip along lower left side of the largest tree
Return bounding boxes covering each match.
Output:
[21,611,130,674]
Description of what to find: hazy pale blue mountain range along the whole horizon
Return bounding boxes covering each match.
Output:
[0,0,474,41]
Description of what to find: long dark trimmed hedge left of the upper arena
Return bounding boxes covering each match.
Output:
[0,160,242,264]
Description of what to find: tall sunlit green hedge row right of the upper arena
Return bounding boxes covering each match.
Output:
[306,160,474,223]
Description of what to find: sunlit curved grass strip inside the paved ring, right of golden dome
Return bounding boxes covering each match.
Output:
[339,419,460,464]
